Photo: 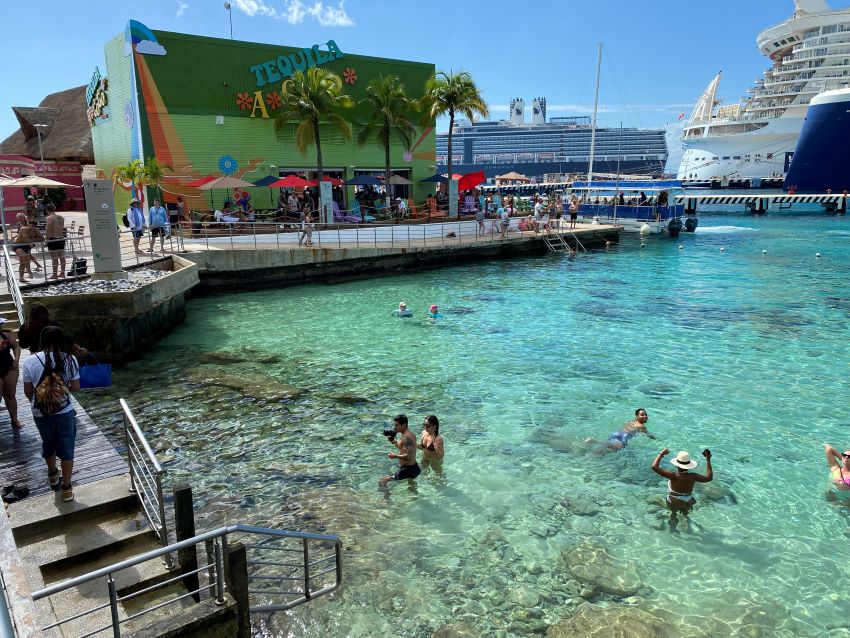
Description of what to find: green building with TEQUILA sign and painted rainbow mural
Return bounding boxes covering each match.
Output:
[92,20,436,213]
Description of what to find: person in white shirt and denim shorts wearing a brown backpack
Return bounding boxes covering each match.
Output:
[22,326,80,502]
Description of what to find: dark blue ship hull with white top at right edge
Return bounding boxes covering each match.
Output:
[785,88,850,193]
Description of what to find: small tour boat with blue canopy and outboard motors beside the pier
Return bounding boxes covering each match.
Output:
[563,180,684,237]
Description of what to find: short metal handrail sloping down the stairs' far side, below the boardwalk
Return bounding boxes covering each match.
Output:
[118,398,171,567]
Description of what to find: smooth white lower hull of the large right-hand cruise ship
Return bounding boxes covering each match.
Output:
[676,117,805,181]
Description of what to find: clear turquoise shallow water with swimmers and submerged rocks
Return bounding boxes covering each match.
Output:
[81,214,850,636]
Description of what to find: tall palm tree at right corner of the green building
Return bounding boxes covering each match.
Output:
[421,71,490,218]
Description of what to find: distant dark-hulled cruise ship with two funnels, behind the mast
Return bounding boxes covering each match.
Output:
[437,97,667,177]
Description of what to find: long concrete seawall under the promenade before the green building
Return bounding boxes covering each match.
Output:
[184,226,621,292]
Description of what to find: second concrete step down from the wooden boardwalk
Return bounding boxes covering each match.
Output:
[18,512,156,580]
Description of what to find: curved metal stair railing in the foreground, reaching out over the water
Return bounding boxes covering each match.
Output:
[32,524,342,638]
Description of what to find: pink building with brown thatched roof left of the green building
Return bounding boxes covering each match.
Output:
[0,86,94,220]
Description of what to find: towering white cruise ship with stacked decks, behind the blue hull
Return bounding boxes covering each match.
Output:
[677,0,850,182]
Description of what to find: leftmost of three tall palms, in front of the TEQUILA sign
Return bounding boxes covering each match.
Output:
[274,67,354,218]
